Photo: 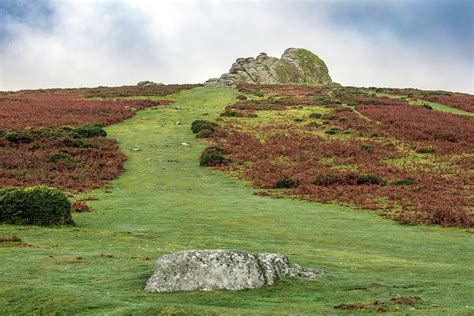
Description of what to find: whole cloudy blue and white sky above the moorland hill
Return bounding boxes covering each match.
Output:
[0,0,474,93]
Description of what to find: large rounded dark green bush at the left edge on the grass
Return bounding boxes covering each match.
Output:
[0,186,74,226]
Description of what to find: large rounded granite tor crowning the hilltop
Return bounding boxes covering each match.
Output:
[205,48,332,86]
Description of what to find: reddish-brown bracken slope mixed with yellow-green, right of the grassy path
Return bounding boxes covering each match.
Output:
[207,85,474,227]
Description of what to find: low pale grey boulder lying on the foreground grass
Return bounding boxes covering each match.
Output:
[145,250,320,292]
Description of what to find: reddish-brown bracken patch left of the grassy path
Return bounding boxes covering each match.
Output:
[0,85,193,192]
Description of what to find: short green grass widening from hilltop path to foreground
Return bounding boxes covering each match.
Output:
[0,88,474,315]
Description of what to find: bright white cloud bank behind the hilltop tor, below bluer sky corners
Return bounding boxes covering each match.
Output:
[0,0,474,93]
